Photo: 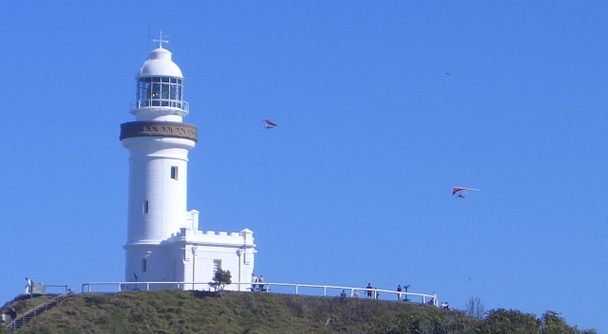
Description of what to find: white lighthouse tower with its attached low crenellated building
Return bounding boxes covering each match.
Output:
[120,41,256,290]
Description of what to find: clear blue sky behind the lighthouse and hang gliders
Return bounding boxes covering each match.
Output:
[0,1,608,333]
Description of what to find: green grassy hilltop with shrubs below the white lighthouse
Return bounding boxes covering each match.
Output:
[0,290,595,334]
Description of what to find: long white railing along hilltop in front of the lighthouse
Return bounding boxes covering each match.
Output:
[80,282,439,306]
